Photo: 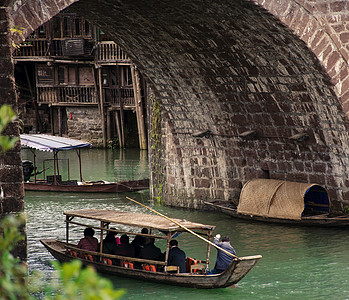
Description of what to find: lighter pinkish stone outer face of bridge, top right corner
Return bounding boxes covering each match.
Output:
[254,0,349,116]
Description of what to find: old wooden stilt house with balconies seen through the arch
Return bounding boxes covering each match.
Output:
[14,10,147,149]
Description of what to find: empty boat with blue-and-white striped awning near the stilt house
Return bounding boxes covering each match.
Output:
[20,134,149,193]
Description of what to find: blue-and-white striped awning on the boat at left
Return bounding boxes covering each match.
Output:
[21,134,92,152]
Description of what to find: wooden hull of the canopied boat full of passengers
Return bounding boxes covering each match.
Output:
[41,240,262,289]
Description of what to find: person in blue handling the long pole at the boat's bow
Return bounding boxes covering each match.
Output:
[211,234,236,274]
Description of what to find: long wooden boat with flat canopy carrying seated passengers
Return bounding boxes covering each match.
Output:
[41,209,262,289]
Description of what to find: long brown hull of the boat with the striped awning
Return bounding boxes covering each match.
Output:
[24,179,149,193]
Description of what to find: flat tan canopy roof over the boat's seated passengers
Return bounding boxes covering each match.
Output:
[64,209,215,231]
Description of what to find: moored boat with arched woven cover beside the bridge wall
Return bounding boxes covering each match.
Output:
[205,179,349,227]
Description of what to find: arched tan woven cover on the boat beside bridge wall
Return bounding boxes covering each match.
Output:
[237,179,326,220]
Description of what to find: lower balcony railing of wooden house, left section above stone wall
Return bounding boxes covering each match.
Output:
[37,87,97,103]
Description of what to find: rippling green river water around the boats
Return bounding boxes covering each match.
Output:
[22,149,349,300]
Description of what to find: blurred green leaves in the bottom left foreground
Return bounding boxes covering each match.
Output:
[0,215,125,300]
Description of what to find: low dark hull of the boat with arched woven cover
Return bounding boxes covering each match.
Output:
[205,201,349,227]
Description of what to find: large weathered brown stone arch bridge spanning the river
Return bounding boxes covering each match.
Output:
[0,0,349,219]
